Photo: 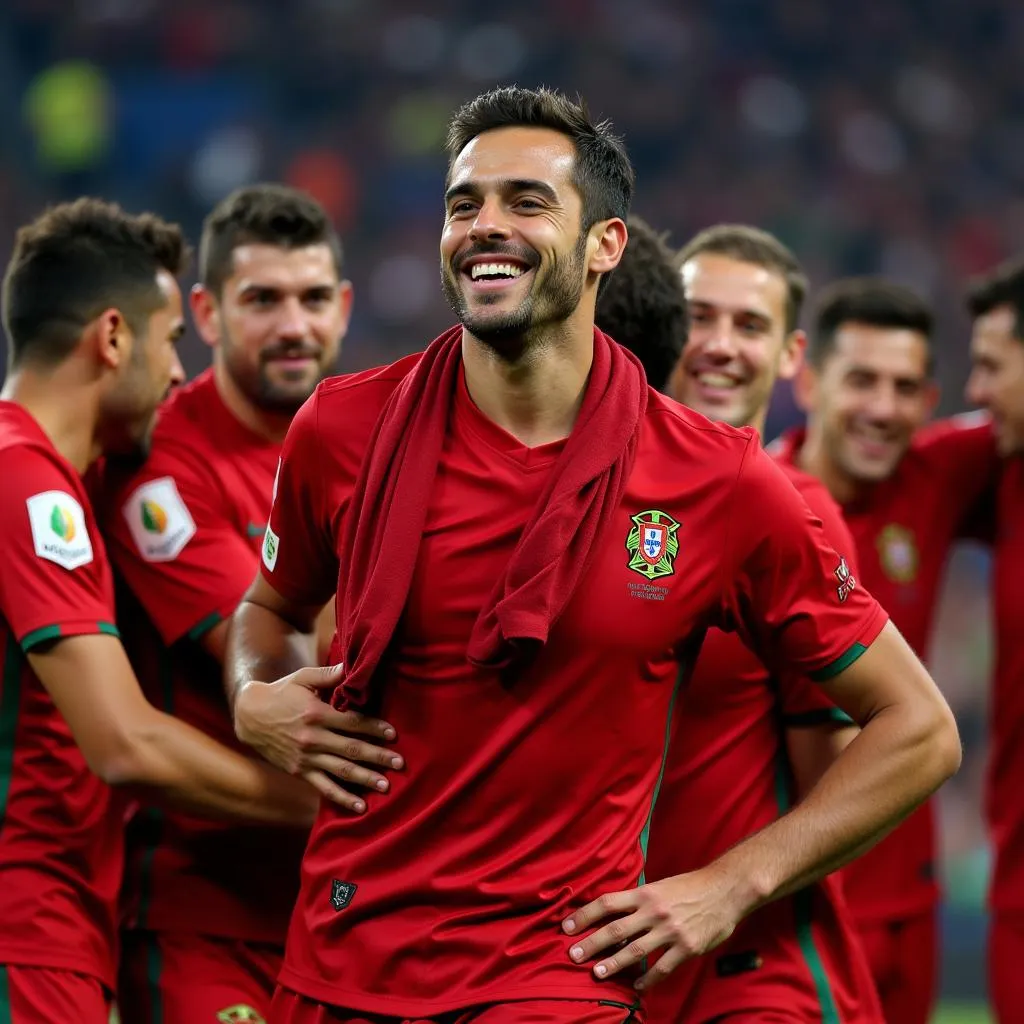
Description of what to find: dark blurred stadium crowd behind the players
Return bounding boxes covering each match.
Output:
[0,0,1007,1024]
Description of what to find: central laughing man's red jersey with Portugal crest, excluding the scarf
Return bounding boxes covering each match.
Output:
[263,356,886,1017]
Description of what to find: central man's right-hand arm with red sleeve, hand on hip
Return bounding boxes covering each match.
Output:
[563,444,961,988]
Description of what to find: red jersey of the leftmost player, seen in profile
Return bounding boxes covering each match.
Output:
[0,401,126,988]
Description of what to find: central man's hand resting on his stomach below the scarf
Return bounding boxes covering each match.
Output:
[234,665,404,814]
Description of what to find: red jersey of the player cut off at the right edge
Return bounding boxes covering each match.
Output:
[985,457,1024,913]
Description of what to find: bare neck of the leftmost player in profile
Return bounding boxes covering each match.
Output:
[0,358,102,474]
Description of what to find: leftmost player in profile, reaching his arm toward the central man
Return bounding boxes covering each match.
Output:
[0,199,335,1024]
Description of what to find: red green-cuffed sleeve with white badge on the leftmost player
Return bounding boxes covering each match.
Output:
[0,447,118,650]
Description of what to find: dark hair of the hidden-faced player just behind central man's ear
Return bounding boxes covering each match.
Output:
[595,216,689,391]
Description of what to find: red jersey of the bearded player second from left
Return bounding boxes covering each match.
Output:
[101,371,306,943]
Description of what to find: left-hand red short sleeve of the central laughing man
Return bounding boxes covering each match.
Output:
[260,389,338,605]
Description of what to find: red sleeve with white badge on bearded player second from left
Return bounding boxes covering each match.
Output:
[103,442,258,644]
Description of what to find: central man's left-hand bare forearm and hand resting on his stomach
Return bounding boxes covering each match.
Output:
[224,575,403,813]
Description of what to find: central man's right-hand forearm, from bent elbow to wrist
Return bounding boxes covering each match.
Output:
[712,707,958,914]
